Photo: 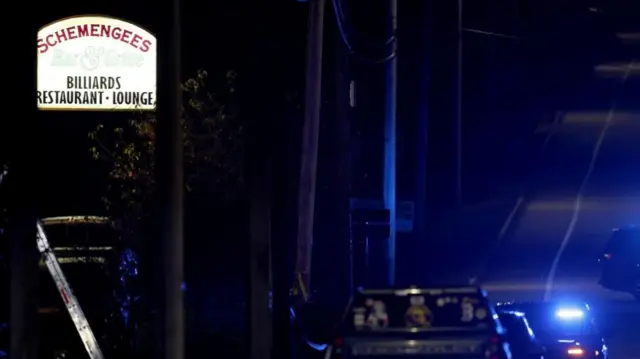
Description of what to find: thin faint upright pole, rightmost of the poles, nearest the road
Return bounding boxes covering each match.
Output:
[453,0,464,206]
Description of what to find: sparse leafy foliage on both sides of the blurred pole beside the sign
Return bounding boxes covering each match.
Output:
[88,70,244,240]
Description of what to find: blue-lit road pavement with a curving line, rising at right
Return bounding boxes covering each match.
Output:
[480,34,640,359]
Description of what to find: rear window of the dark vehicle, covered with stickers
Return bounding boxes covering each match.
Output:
[343,290,493,332]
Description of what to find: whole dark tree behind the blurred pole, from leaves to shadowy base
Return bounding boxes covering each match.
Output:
[88,71,245,352]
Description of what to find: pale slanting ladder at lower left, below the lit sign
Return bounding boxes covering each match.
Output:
[36,221,104,359]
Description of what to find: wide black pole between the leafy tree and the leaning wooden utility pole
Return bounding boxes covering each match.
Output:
[241,5,274,359]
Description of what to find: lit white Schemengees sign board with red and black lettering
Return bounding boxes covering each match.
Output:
[38,16,157,111]
